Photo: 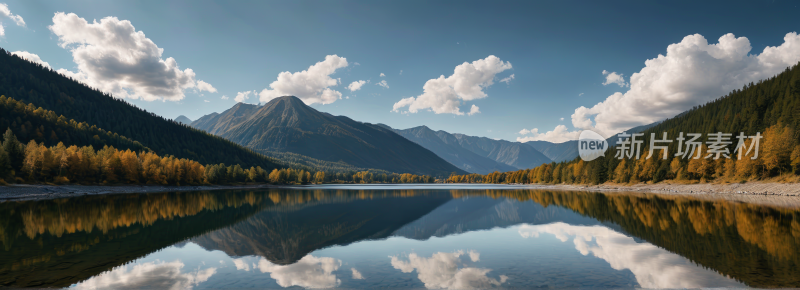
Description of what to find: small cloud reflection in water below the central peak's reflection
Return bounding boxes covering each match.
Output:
[258,255,342,288]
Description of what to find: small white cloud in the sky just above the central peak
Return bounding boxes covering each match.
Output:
[259,55,348,105]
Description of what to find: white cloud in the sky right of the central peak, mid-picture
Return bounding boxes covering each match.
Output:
[392,55,511,115]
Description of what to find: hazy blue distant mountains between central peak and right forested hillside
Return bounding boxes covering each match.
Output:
[390,125,552,174]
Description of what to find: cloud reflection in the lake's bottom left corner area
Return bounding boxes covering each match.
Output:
[75,261,217,290]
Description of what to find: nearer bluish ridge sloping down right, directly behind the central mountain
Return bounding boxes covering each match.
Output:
[394,125,517,174]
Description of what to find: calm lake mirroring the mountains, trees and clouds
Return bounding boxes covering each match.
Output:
[0,185,800,289]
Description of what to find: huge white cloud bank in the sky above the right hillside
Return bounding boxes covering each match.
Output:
[536,32,800,142]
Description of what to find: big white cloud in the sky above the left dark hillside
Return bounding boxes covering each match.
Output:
[48,12,216,101]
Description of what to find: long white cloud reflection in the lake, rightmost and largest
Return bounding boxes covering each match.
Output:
[518,222,744,289]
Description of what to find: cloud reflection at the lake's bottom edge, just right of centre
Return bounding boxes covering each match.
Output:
[389,251,508,289]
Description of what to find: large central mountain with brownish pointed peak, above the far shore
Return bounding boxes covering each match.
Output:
[192,97,464,176]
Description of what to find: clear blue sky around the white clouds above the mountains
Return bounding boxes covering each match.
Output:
[0,1,800,142]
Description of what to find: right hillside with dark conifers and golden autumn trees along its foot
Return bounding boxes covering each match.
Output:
[449,65,800,183]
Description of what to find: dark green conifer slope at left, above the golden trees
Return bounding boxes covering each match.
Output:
[0,49,279,170]
